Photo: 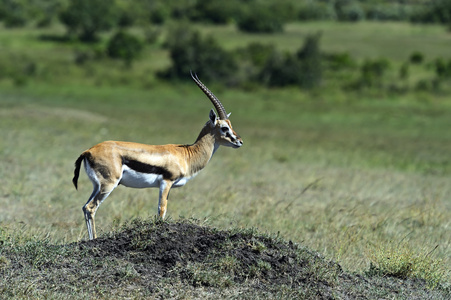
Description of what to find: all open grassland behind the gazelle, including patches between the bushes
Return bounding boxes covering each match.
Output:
[0,23,451,290]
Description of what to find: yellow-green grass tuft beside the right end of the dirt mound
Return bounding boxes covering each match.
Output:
[367,245,445,288]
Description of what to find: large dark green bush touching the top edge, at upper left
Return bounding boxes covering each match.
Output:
[60,0,119,42]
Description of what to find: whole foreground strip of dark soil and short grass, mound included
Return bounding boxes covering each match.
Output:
[0,220,449,299]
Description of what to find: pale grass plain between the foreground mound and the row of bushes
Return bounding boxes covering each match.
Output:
[0,86,451,288]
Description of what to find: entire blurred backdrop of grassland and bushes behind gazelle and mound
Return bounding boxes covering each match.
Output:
[0,0,451,279]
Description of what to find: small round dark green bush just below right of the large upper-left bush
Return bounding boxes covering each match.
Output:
[107,31,143,67]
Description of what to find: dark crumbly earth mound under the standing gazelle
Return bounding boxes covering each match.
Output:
[78,221,341,298]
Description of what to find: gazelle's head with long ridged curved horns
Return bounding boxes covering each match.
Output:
[191,73,243,148]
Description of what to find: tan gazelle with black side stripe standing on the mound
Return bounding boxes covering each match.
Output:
[72,73,243,240]
